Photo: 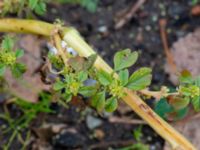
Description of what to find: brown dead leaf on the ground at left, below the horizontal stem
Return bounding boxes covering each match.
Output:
[5,35,50,102]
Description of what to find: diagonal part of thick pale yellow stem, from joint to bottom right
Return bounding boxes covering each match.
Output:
[63,29,195,150]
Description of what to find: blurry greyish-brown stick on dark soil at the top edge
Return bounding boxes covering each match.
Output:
[115,0,146,29]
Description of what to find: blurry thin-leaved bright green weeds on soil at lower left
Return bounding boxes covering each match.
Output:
[0,92,53,150]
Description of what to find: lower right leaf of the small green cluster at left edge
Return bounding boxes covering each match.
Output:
[11,63,26,78]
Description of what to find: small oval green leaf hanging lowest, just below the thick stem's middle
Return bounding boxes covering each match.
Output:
[105,97,118,112]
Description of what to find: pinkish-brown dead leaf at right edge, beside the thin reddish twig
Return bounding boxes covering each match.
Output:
[165,28,200,84]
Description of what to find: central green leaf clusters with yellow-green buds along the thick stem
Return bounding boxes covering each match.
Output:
[54,49,151,112]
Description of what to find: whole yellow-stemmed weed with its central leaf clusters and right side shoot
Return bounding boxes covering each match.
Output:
[0,19,196,149]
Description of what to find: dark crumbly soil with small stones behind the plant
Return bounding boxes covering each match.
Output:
[0,0,200,150]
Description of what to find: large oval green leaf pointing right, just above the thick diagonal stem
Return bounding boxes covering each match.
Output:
[126,67,152,90]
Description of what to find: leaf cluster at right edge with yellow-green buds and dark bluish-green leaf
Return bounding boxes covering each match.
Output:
[155,70,200,120]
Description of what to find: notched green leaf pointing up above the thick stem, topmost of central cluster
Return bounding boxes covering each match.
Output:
[114,49,138,71]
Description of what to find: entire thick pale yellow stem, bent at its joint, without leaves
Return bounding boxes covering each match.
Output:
[0,19,196,150]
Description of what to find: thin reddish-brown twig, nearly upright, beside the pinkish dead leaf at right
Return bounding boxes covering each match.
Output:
[159,19,177,74]
